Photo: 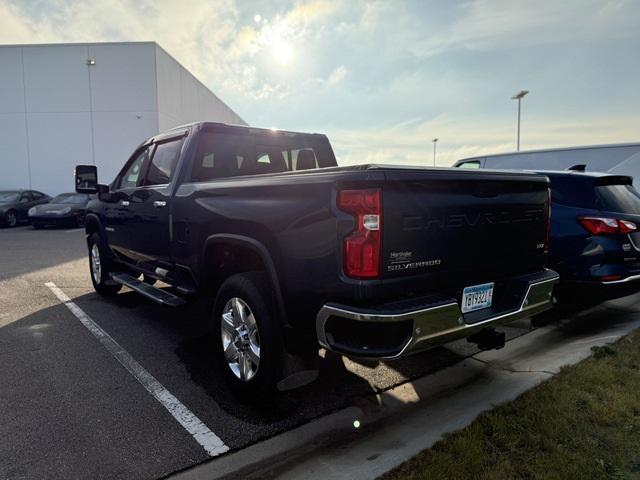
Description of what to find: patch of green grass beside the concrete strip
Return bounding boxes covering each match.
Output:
[383,331,640,480]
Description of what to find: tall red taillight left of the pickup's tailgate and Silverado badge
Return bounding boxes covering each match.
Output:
[338,188,382,278]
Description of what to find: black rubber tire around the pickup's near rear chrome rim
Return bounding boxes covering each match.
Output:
[210,272,284,403]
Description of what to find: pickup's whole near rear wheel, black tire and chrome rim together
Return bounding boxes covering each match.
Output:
[212,273,283,401]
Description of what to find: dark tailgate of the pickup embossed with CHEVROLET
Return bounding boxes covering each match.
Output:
[381,169,549,288]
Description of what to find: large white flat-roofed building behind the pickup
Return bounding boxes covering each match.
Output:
[0,42,246,195]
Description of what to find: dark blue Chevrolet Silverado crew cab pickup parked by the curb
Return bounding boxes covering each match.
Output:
[76,123,558,398]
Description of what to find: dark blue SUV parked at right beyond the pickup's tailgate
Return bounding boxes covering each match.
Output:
[538,171,640,304]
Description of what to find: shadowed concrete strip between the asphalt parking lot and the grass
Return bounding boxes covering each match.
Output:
[169,297,640,480]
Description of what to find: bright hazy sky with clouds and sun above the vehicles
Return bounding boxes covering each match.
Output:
[0,0,640,165]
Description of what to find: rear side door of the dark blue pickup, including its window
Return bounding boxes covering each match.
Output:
[119,135,184,271]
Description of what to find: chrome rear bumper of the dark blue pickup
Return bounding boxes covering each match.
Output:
[316,270,560,359]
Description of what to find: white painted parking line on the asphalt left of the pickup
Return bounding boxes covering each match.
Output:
[45,282,229,457]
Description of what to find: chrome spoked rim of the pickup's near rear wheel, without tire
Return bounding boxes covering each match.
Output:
[220,297,260,382]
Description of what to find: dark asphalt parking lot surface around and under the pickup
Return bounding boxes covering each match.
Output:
[0,227,624,479]
